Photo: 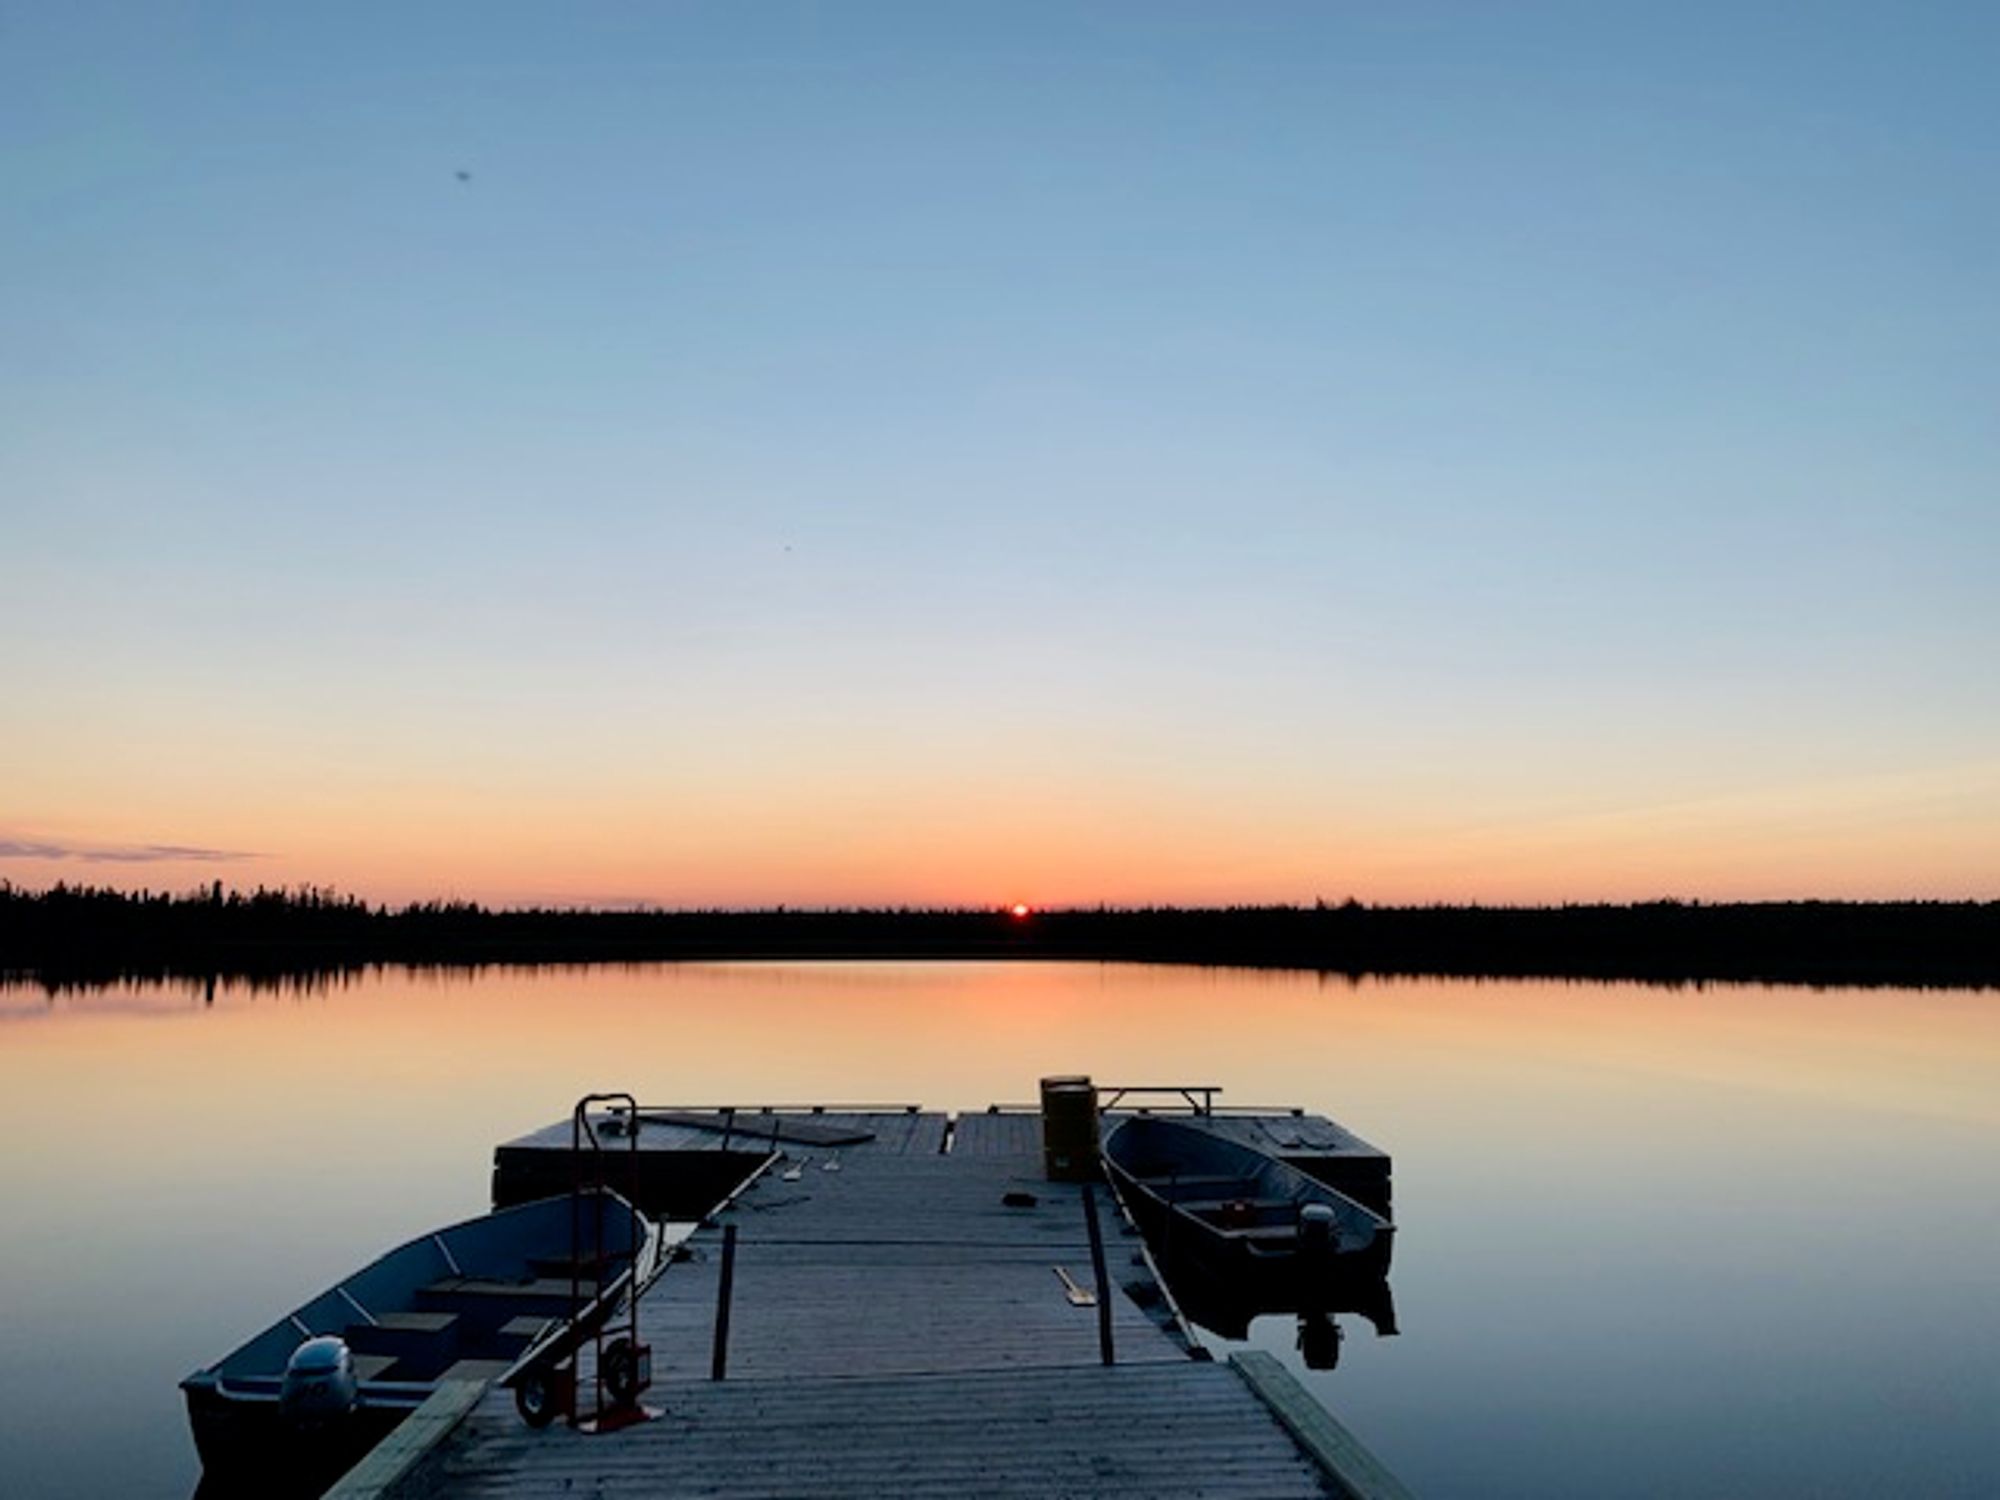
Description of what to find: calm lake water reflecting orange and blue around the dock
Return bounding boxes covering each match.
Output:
[0,964,2000,1498]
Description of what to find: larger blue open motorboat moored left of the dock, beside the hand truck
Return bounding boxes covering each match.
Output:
[180,1192,664,1494]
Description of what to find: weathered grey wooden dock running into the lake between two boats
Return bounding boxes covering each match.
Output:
[340,1108,1404,1500]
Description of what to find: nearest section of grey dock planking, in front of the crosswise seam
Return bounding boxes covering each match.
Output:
[432,1360,1330,1500]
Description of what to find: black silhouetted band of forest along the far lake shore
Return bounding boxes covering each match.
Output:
[0,882,2000,988]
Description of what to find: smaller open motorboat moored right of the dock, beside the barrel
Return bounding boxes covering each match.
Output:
[1104,1114,1396,1308]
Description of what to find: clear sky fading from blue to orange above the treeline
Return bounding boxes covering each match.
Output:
[0,0,2000,906]
